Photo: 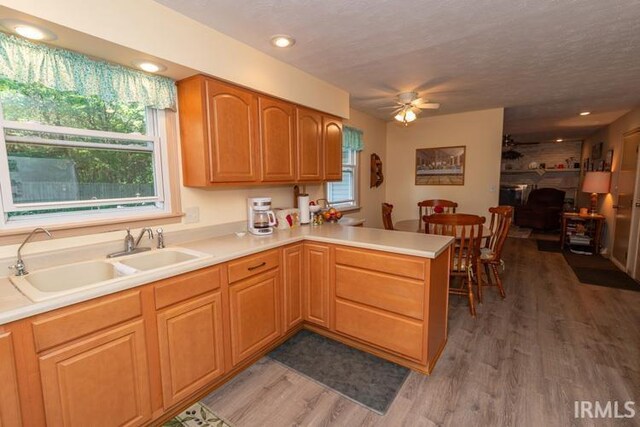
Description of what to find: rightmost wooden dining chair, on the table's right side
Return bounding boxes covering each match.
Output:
[478,206,513,302]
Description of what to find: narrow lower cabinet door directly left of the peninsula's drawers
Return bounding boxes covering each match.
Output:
[304,244,329,327]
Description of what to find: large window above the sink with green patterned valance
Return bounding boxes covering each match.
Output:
[0,33,175,226]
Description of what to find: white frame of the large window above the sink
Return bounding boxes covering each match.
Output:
[0,106,171,229]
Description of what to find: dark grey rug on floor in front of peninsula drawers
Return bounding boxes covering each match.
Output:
[268,331,409,415]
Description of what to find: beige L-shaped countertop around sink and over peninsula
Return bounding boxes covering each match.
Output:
[0,224,453,324]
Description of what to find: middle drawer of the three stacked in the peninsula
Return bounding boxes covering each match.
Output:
[336,265,424,320]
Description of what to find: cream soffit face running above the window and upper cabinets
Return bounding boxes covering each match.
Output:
[0,0,349,117]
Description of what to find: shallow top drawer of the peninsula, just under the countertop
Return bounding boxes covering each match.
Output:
[336,247,425,280]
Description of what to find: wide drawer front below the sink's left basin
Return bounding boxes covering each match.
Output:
[32,291,142,352]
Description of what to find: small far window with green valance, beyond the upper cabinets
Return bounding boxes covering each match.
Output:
[326,126,363,209]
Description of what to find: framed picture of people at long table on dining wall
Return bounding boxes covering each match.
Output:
[415,145,467,185]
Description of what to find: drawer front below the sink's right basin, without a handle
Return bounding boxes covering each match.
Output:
[154,267,222,309]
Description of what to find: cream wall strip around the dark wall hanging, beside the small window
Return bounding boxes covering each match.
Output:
[345,109,387,228]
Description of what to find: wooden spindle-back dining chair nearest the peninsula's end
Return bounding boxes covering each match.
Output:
[423,214,485,317]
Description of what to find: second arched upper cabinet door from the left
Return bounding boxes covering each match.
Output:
[258,96,296,182]
